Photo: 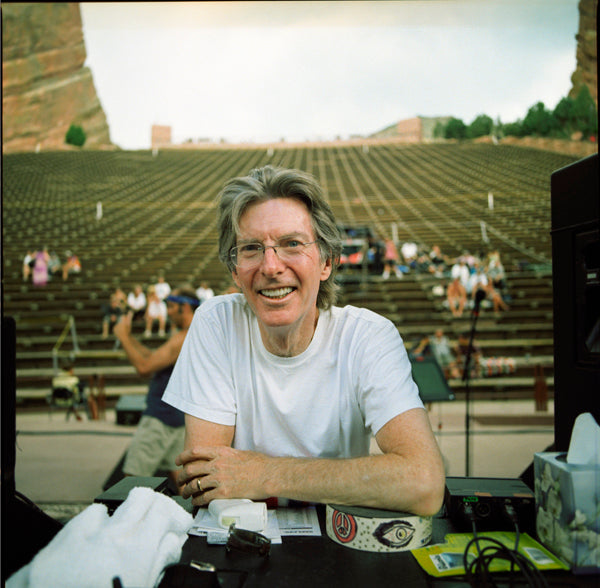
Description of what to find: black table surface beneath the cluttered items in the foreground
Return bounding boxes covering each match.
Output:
[181,505,600,588]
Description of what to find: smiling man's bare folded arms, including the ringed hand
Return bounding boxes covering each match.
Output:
[175,408,445,516]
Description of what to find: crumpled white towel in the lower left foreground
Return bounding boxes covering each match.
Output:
[6,487,193,588]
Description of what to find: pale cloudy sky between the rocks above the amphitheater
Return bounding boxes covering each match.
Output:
[81,0,579,149]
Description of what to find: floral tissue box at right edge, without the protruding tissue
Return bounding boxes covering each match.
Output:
[533,452,600,573]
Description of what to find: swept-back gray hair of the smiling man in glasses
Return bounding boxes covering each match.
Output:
[218,165,342,310]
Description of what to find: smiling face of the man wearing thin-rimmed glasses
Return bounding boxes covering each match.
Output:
[232,198,331,336]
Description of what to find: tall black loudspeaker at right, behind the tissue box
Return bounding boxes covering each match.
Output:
[551,154,600,451]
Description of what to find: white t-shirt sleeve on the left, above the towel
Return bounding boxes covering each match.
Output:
[163,304,236,426]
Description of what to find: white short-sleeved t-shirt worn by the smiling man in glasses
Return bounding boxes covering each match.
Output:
[163,294,423,458]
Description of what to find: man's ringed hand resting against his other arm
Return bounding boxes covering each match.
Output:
[175,446,272,506]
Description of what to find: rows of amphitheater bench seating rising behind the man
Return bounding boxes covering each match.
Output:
[2,142,575,400]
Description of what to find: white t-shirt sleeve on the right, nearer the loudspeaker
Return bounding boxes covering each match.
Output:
[354,319,423,435]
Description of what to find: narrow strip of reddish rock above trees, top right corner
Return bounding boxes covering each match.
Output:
[569,0,598,104]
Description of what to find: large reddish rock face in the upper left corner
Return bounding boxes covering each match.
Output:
[2,3,112,153]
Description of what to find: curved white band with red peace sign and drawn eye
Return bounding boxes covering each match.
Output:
[325,504,432,553]
